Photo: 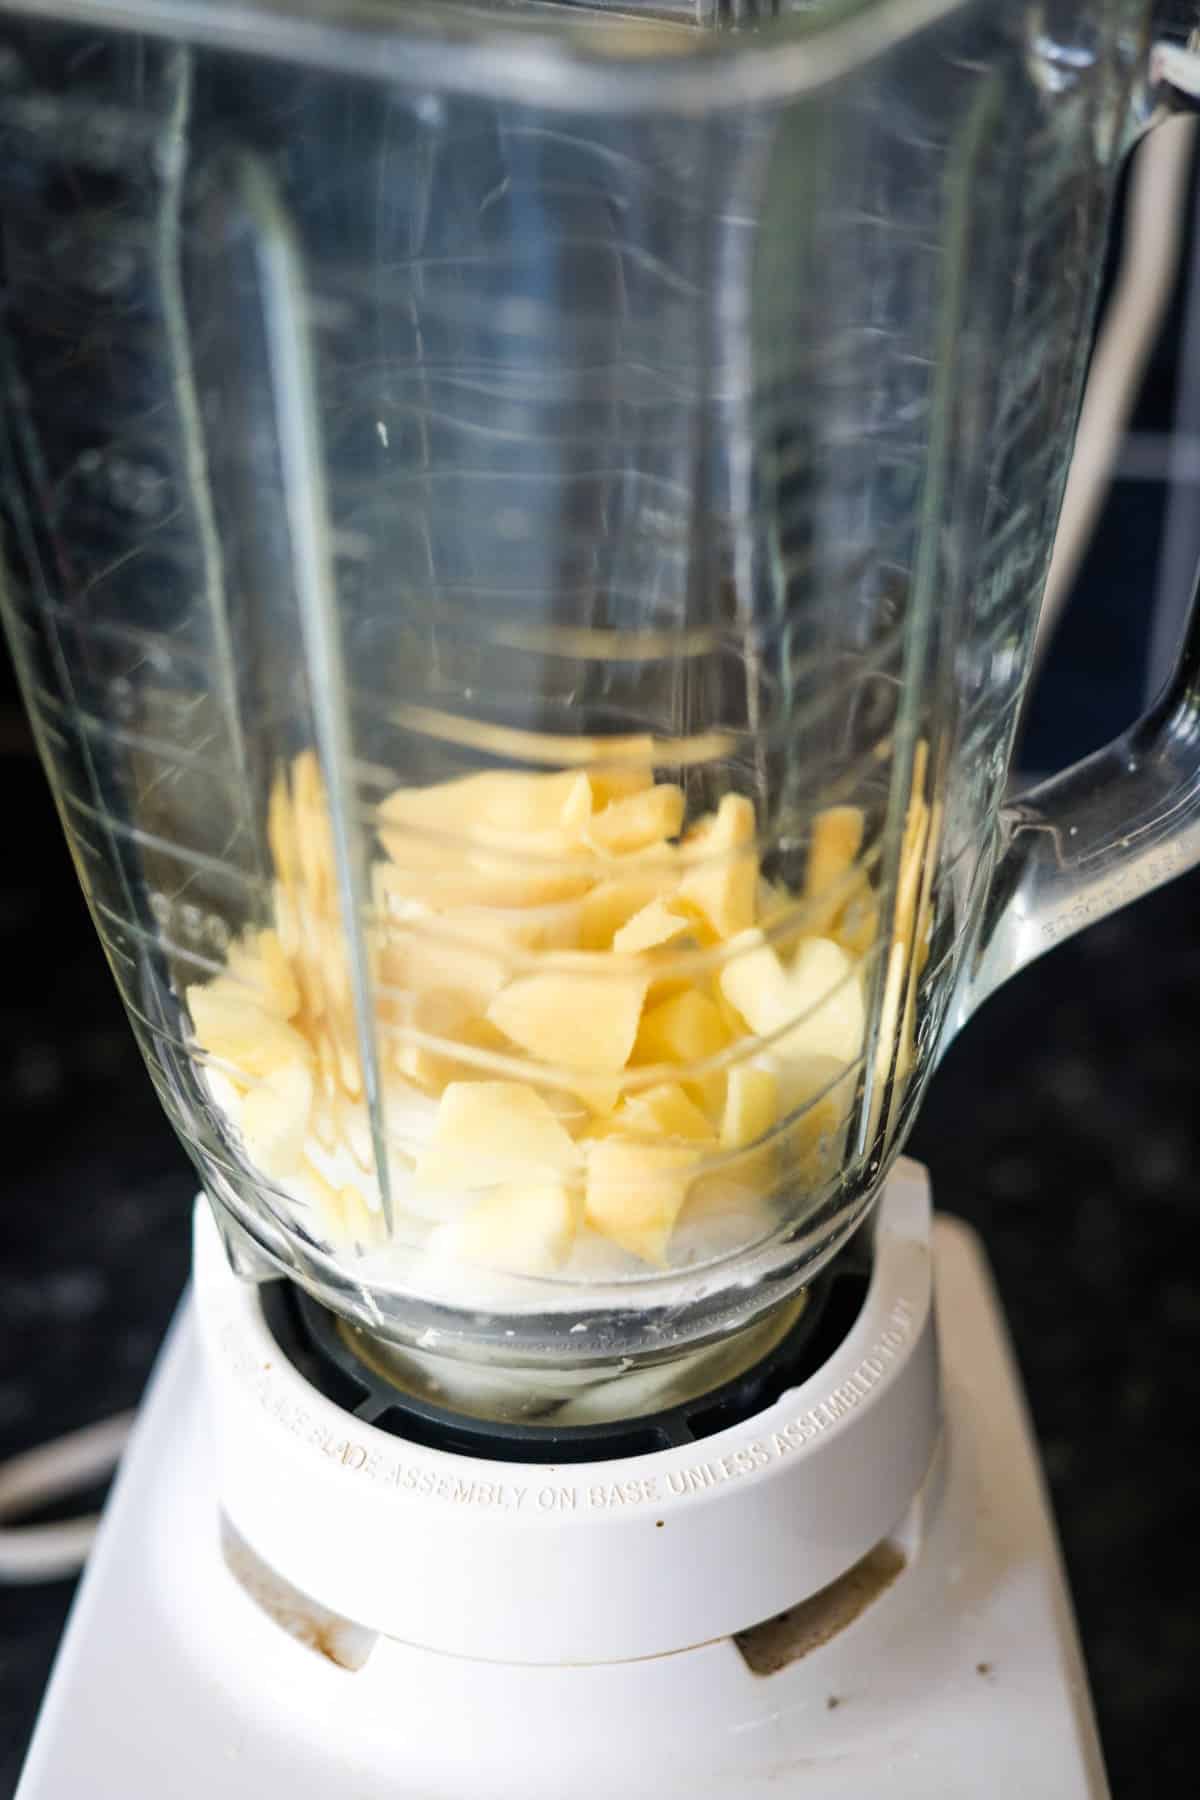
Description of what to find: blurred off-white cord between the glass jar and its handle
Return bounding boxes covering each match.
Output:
[1033,119,1196,671]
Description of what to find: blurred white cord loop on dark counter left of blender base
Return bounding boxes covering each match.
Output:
[0,1413,133,1582]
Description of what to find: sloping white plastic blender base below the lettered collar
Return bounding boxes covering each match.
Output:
[16,1188,1108,1800]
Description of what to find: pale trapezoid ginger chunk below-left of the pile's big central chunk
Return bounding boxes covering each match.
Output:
[416,1082,579,1188]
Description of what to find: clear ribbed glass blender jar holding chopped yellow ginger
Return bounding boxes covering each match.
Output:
[0,0,1198,1424]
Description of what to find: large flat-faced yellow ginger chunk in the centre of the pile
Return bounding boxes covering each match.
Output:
[488,968,649,1073]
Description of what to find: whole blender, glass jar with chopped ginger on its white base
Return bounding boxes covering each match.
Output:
[0,0,1200,1800]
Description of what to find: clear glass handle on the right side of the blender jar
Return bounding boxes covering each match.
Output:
[946,17,1200,1042]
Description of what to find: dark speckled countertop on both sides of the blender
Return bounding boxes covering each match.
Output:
[0,713,1200,1800]
